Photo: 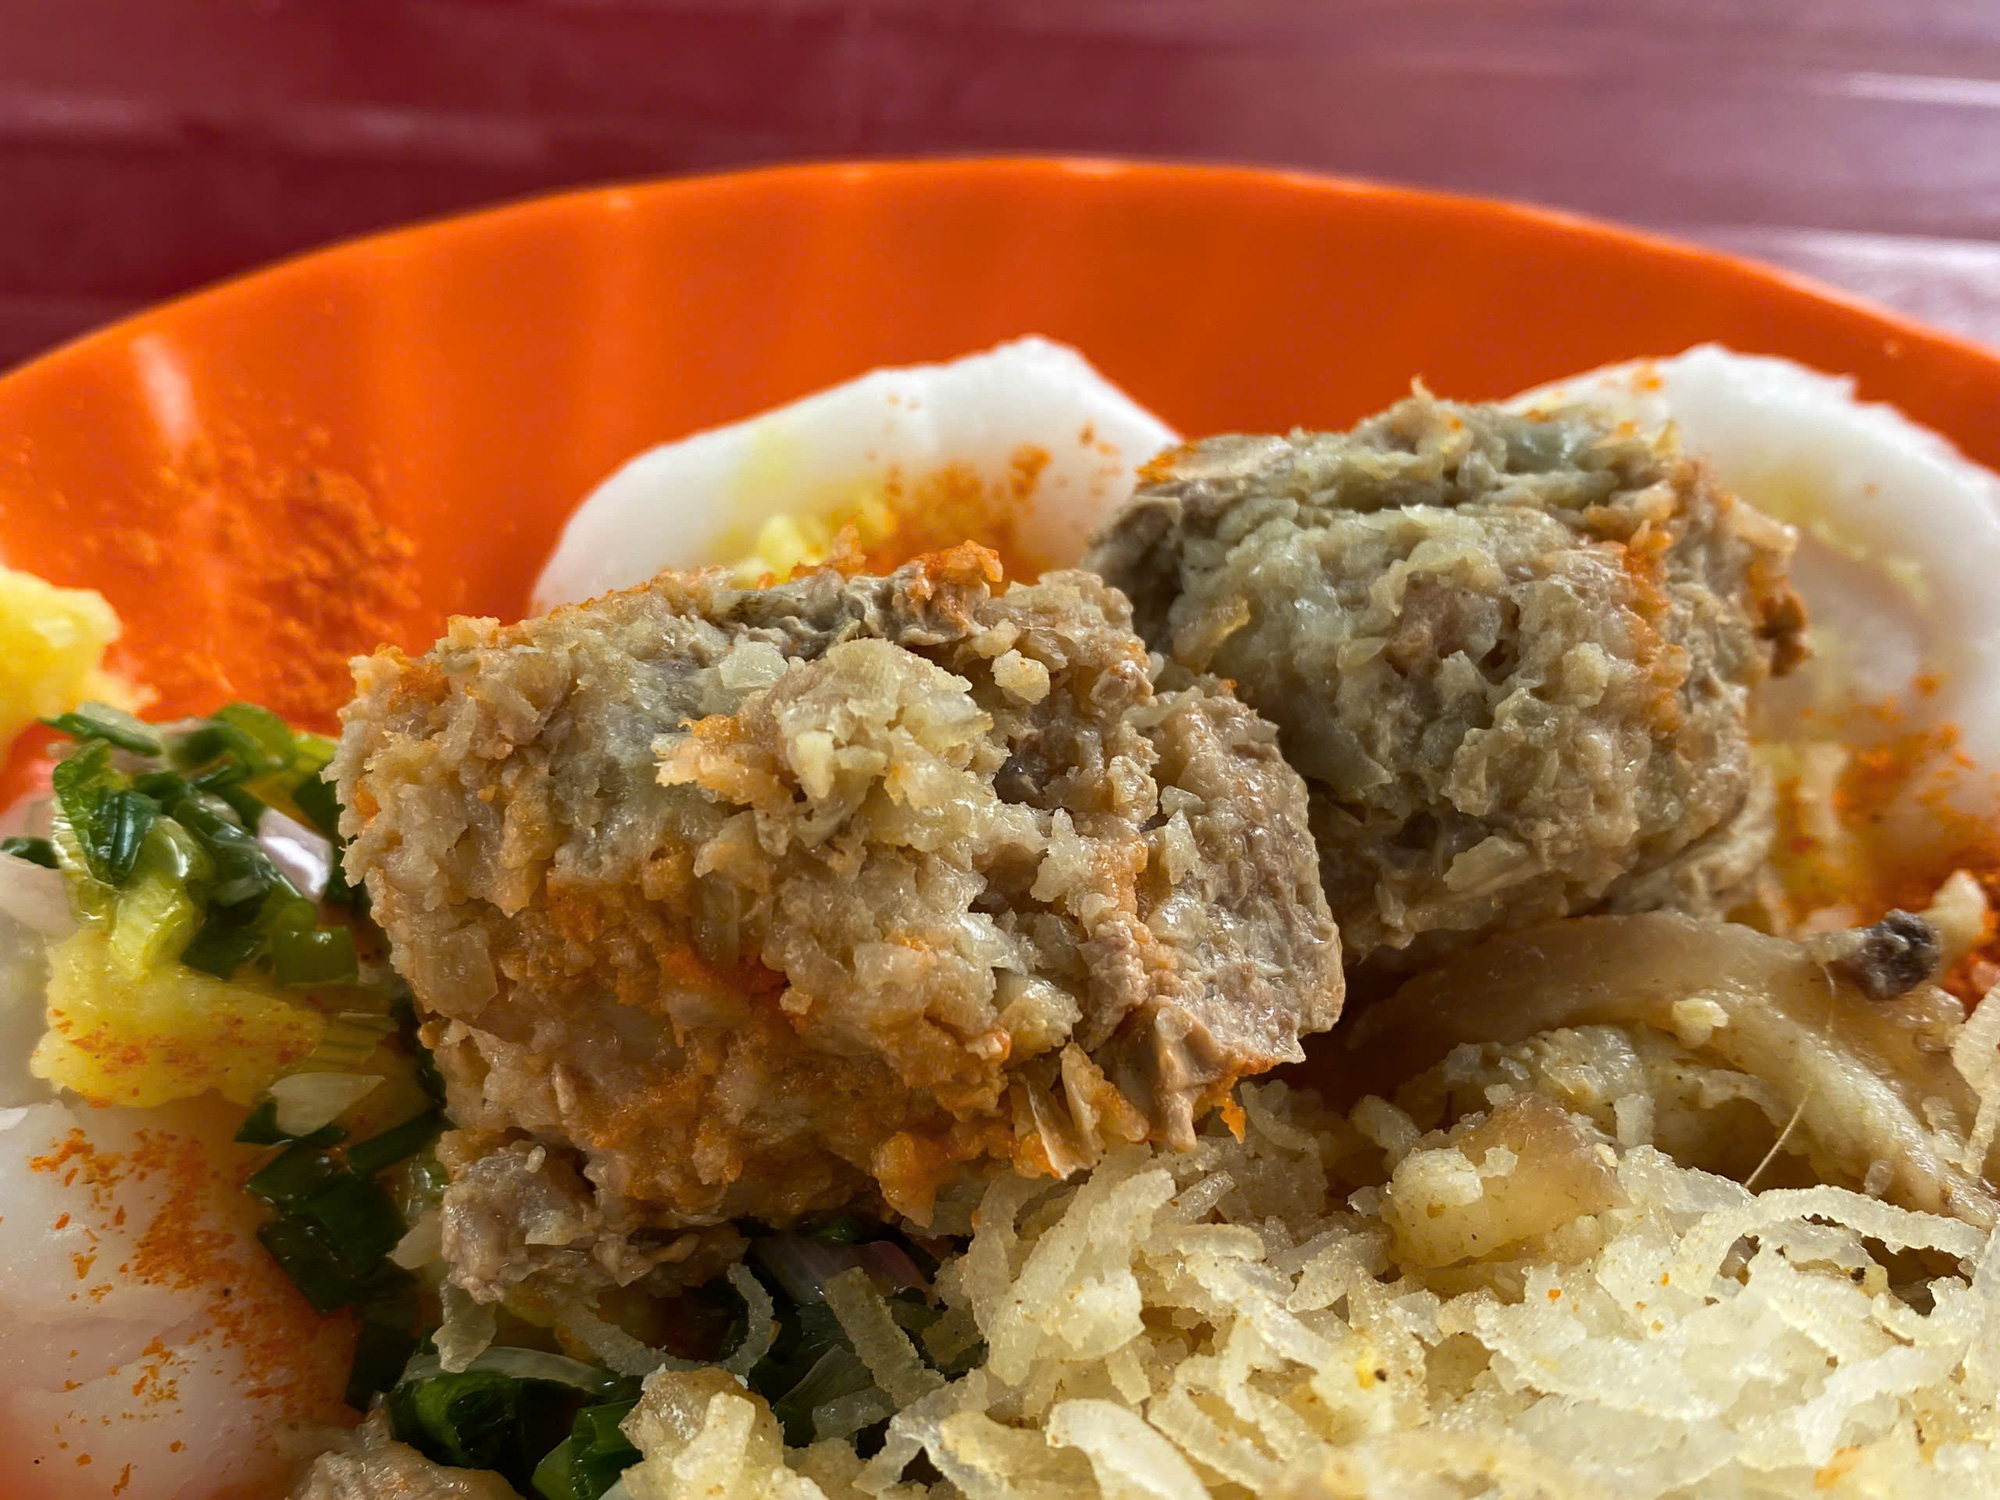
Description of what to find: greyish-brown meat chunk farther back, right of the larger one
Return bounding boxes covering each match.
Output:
[1086,388,1804,968]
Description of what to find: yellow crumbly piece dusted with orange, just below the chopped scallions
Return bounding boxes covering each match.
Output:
[28,928,326,1108]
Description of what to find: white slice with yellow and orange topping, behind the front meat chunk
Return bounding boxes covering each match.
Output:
[534,338,1178,610]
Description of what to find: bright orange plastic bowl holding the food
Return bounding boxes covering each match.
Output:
[0,160,2000,752]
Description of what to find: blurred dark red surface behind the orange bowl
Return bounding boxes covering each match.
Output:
[0,0,2000,368]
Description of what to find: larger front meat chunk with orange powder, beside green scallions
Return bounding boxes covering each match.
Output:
[336,546,1342,1286]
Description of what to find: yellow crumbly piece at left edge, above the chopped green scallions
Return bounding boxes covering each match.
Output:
[0,566,136,748]
